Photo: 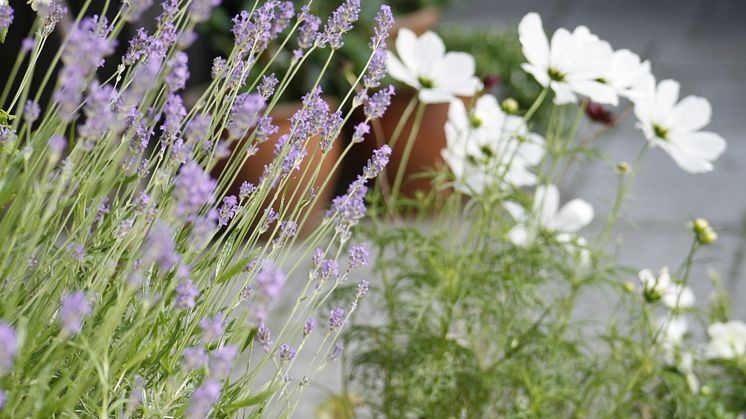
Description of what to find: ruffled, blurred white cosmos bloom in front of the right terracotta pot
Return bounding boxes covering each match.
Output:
[441,94,544,195]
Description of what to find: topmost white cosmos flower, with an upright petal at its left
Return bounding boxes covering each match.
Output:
[518,13,619,105]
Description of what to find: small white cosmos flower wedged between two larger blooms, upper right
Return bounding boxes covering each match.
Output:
[601,49,651,100]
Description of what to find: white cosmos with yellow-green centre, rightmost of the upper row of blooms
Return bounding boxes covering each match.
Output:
[635,76,725,173]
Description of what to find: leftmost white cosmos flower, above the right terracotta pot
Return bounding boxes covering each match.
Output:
[387,28,482,103]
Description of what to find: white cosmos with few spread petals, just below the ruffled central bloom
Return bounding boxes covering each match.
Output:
[503,185,594,246]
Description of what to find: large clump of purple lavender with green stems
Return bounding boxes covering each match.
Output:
[0,0,394,418]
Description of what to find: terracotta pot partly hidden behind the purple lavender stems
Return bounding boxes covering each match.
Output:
[215,103,343,234]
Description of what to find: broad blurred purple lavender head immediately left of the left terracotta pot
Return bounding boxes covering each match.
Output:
[174,161,217,215]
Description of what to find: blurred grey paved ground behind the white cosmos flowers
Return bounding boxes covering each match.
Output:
[296,0,746,418]
